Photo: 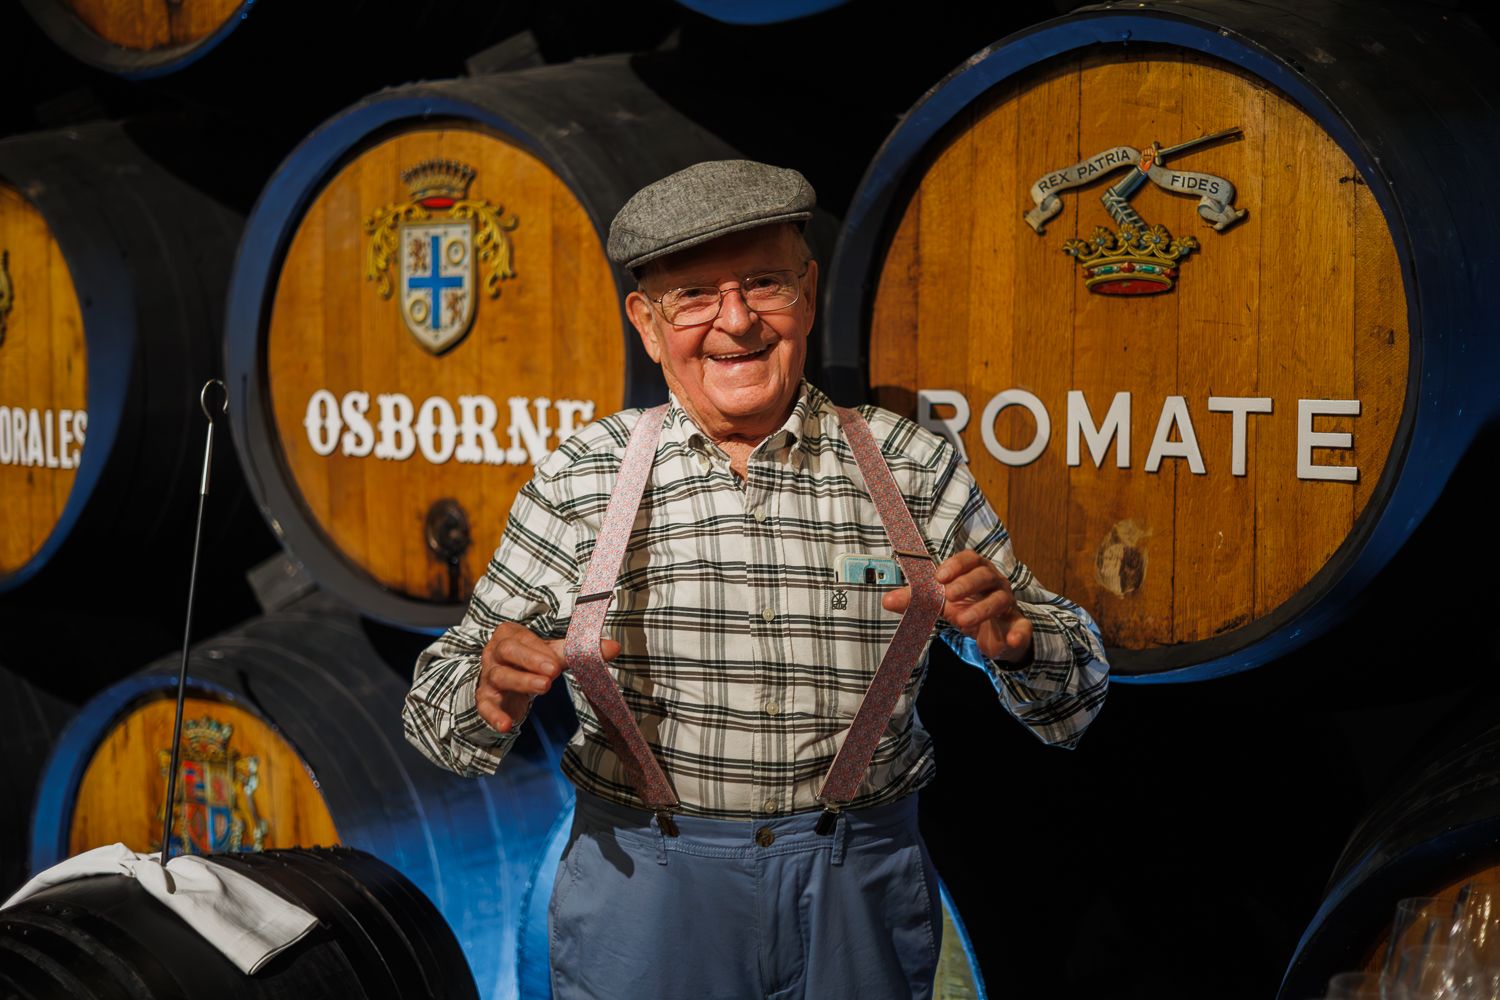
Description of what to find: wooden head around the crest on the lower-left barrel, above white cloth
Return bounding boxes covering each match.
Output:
[68,696,339,853]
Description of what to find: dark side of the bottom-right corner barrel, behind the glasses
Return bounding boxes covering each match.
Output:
[1280,720,1500,1000]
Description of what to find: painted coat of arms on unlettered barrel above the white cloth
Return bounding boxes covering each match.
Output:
[159,717,270,855]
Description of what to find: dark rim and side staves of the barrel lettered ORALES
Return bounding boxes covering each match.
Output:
[0,123,256,597]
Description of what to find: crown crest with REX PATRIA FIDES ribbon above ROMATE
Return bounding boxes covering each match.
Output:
[1025,127,1245,295]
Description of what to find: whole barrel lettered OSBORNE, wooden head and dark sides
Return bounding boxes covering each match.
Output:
[225,58,734,630]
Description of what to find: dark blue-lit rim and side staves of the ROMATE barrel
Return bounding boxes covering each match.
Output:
[822,0,1500,684]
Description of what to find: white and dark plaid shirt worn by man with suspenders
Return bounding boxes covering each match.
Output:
[402,382,1109,819]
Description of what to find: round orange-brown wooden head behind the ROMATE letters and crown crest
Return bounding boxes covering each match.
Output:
[870,48,1409,649]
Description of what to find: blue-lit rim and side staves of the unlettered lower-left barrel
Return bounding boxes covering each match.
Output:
[30,605,576,996]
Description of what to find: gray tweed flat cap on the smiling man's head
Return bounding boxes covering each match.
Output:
[609,160,816,268]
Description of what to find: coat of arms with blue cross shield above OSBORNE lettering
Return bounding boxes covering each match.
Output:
[365,160,518,354]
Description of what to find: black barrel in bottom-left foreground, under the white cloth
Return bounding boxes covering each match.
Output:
[0,849,479,1000]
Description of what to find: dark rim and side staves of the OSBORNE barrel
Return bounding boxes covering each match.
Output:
[225,57,738,634]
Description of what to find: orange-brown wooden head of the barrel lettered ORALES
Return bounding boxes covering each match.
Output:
[0,184,89,576]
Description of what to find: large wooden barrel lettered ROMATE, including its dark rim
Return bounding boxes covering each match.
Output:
[824,0,1500,681]
